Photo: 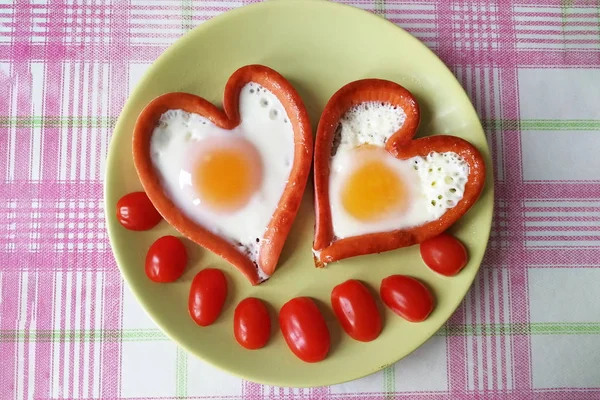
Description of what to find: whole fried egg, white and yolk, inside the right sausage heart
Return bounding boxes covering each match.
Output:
[329,102,469,239]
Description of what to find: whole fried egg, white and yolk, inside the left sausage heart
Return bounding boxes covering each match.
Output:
[150,82,294,279]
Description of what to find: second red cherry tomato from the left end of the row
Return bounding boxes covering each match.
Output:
[146,236,187,283]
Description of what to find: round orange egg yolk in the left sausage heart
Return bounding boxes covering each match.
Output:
[192,143,261,212]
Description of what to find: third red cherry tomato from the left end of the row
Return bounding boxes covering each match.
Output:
[188,268,227,326]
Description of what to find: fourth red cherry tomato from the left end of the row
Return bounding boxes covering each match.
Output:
[233,297,271,350]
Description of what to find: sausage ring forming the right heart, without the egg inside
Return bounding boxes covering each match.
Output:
[313,79,485,267]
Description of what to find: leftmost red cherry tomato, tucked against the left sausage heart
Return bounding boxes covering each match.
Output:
[117,192,162,231]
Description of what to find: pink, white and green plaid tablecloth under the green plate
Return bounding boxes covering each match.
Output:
[0,0,600,400]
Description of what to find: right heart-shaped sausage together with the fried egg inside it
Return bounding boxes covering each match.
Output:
[313,79,485,267]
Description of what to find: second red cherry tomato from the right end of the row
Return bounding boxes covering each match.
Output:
[379,275,434,322]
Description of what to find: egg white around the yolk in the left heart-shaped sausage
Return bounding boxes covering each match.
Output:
[150,82,294,273]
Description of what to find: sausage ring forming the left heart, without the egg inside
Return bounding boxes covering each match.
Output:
[133,65,313,285]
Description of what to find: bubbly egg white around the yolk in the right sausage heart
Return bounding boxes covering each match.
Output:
[329,102,469,238]
